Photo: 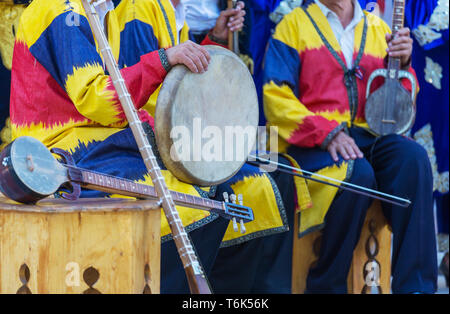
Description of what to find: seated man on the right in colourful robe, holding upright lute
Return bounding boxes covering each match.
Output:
[264,0,437,293]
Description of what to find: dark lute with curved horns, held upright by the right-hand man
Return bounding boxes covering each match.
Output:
[365,0,417,136]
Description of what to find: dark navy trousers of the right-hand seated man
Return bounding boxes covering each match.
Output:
[307,129,437,293]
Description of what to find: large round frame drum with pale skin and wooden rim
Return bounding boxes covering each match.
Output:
[155,46,259,186]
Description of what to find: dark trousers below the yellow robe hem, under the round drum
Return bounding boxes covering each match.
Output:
[210,156,295,294]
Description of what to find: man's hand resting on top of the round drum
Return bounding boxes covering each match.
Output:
[166,40,211,73]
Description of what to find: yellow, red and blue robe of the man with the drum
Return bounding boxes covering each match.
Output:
[11,0,292,245]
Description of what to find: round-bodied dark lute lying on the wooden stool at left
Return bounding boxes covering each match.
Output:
[0,136,253,223]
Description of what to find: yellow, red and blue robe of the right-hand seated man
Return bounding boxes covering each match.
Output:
[264,0,414,234]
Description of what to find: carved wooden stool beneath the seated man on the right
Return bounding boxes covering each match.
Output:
[292,201,391,294]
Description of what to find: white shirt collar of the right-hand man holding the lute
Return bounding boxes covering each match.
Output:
[314,0,364,68]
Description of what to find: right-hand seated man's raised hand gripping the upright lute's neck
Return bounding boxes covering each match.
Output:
[386,27,413,67]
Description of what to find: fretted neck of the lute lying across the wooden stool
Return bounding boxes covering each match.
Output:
[66,165,223,210]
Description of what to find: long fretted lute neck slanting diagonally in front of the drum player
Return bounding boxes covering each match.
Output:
[82,0,211,294]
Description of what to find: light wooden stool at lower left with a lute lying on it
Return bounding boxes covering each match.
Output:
[0,198,161,294]
